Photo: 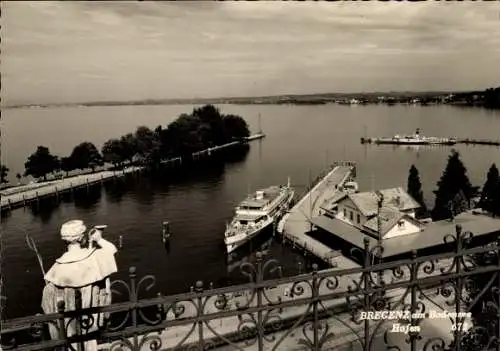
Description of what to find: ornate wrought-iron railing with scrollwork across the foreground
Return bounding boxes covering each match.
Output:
[1,226,500,351]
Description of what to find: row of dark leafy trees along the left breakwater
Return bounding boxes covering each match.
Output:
[21,105,250,180]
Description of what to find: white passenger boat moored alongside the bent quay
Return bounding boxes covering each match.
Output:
[224,180,295,253]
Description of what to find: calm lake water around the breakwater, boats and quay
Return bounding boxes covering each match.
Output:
[1,105,500,317]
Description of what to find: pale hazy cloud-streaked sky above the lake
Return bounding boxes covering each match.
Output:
[1,1,500,105]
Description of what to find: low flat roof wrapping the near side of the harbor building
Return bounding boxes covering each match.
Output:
[311,212,500,257]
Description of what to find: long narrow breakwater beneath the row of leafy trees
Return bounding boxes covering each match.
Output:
[0,132,265,212]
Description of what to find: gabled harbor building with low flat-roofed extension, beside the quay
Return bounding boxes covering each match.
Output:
[308,187,500,263]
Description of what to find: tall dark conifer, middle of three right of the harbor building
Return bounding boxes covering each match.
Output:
[431,150,477,221]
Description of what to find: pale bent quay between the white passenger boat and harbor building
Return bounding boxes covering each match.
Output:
[278,162,358,268]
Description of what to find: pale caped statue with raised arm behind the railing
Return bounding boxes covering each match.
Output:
[42,220,117,351]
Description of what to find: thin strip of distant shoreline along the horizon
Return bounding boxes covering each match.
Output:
[1,91,500,109]
